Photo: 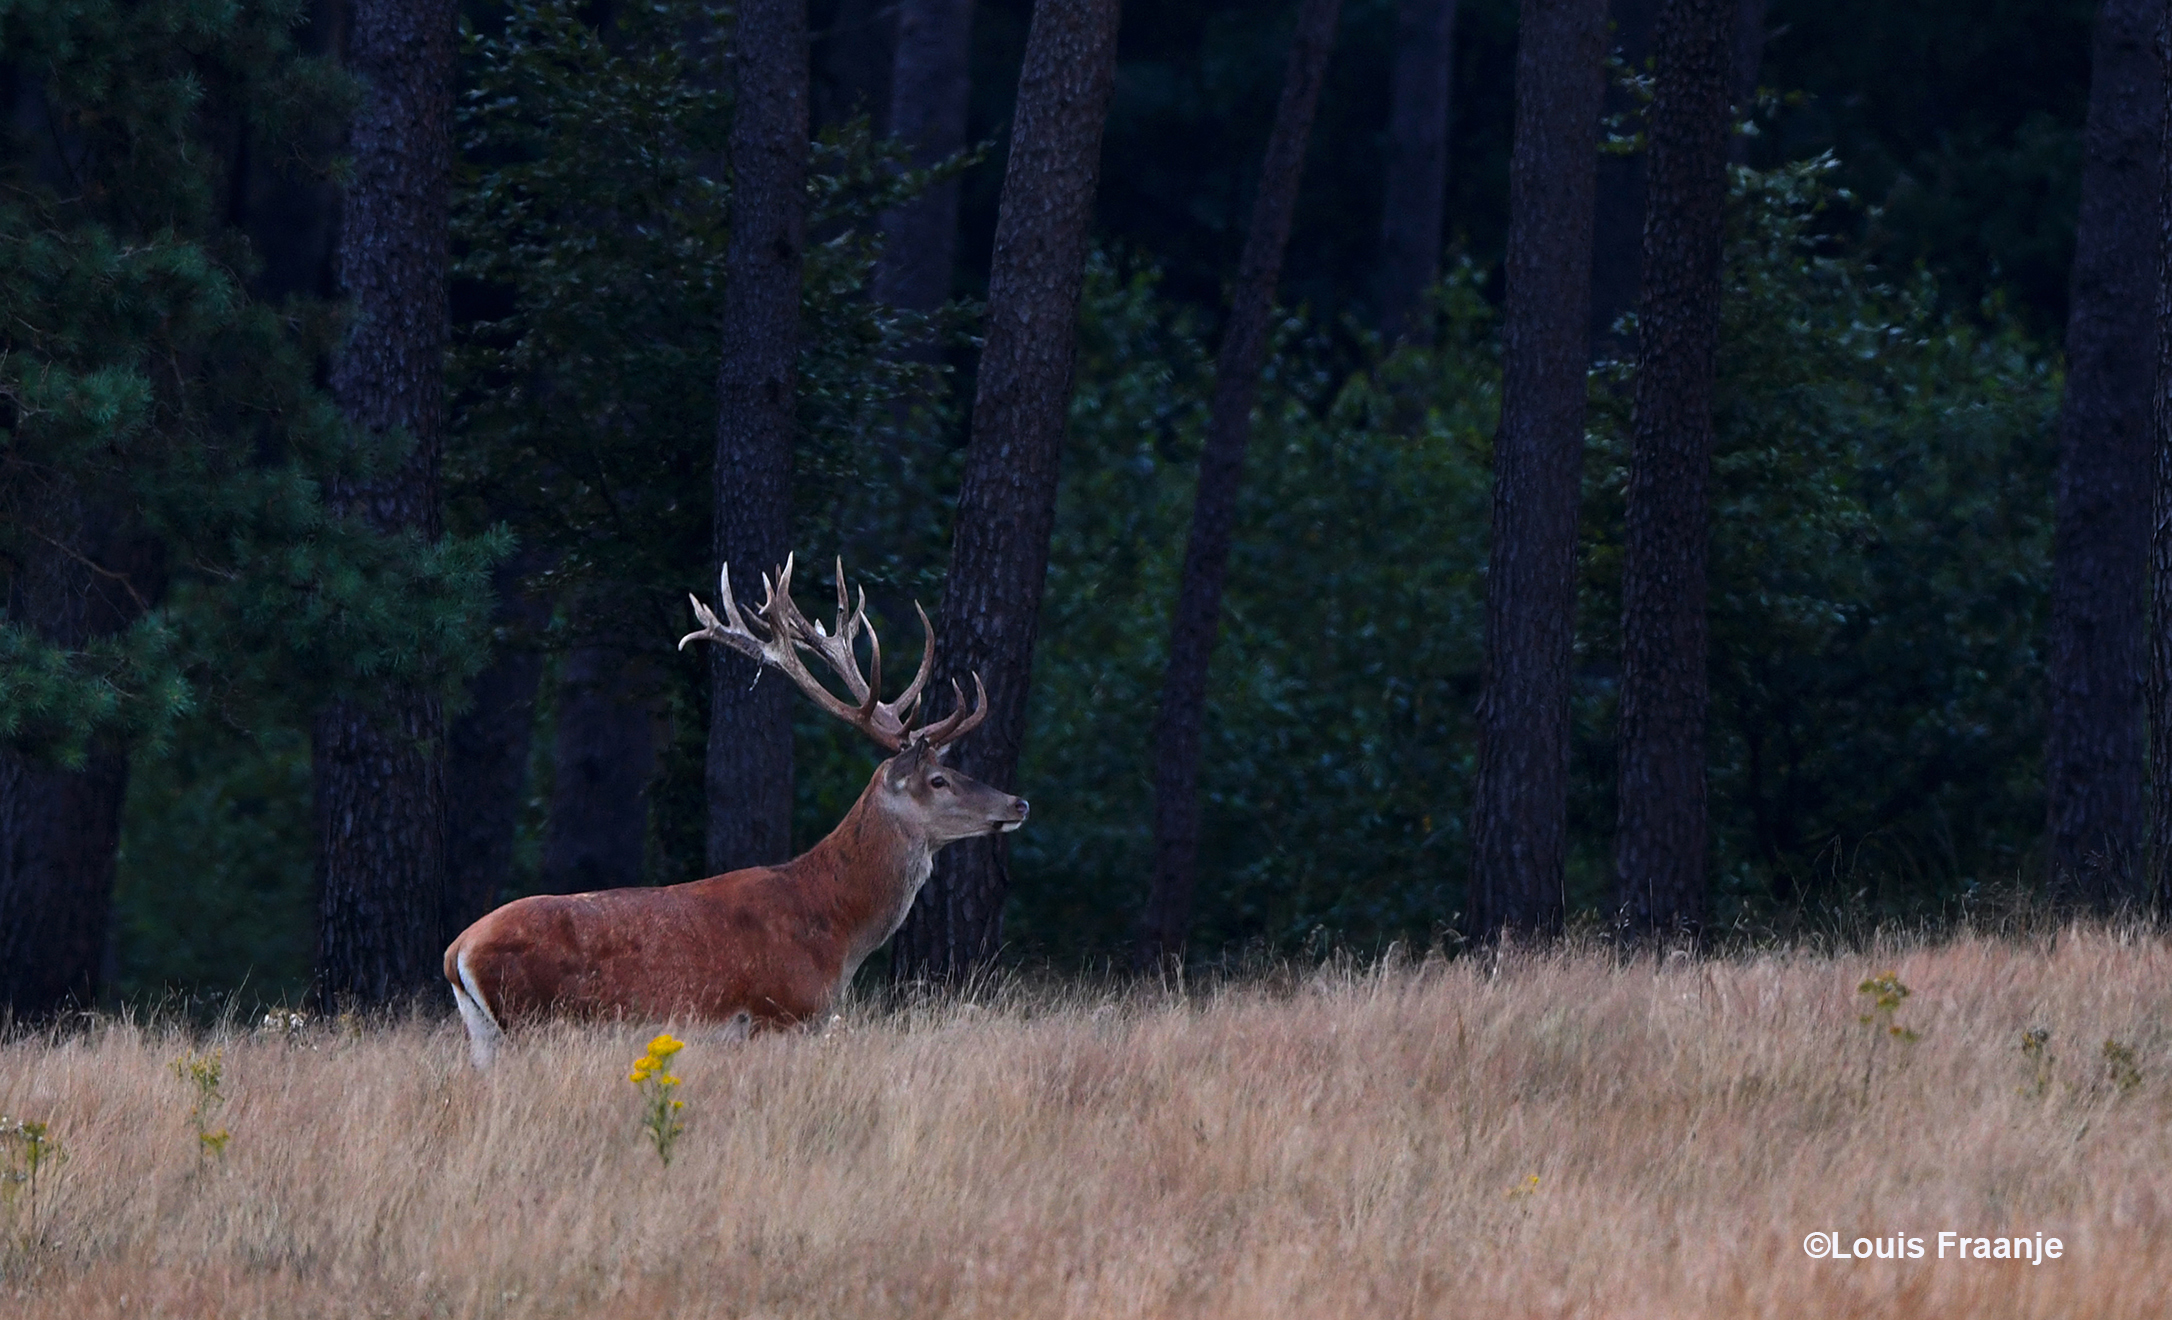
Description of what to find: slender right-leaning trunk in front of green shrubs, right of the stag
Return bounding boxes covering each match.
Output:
[1138,0,1337,966]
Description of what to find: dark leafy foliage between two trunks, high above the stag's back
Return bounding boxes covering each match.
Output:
[447,0,730,599]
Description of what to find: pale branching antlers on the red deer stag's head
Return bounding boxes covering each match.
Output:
[680,556,988,751]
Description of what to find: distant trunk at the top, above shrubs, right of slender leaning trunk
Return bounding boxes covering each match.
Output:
[1377,0,1455,343]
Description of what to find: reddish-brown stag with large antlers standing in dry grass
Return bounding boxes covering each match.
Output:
[445,551,1027,1068]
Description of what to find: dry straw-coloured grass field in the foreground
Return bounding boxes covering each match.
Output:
[0,929,2172,1320]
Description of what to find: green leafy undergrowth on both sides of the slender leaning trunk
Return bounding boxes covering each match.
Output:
[1006,263,1499,962]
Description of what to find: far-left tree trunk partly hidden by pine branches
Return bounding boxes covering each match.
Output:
[0,516,163,1018]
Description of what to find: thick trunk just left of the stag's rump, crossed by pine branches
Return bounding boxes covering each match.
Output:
[315,0,456,1003]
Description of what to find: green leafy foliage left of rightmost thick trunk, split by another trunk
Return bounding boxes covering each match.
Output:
[1579,156,2059,925]
